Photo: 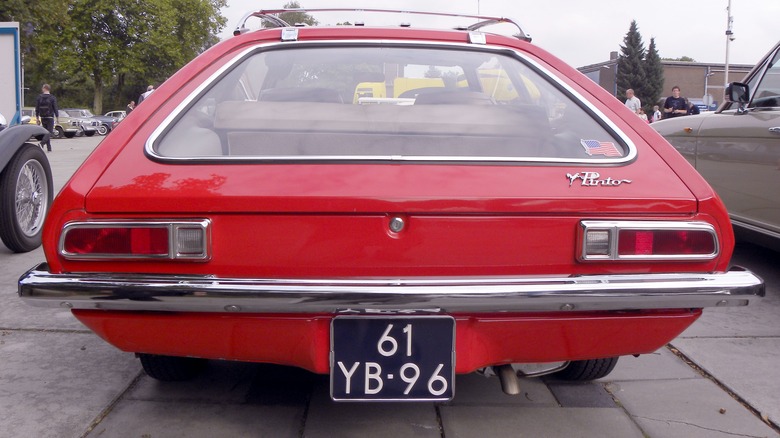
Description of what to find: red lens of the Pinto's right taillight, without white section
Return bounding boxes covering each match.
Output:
[618,230,715,256]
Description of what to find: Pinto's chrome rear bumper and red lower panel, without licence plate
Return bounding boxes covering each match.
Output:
[19,264,764,374]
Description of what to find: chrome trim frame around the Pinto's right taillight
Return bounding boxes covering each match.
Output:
[577,220,720,262]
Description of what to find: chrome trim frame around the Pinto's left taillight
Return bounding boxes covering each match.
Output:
[57,219,211,261]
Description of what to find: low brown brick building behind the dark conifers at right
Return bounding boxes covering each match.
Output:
[577,52,753,109]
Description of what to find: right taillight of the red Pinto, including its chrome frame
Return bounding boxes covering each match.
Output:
[580,221,719,260]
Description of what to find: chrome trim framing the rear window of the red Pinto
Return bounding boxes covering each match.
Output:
[144,40,637,165]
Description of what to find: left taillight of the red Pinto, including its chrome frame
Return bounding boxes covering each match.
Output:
[60,220,210,260]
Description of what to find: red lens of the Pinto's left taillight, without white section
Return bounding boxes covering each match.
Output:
[63,227,170,256]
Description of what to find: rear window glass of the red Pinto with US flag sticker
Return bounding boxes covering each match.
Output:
[147,45,629,161]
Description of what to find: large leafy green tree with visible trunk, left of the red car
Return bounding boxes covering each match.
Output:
[62,0,226,113]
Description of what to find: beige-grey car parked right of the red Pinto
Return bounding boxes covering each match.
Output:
[653,43,780,248]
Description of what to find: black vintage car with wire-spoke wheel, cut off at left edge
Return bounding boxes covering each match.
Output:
[0,114,54,252]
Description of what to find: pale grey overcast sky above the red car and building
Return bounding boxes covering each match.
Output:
[221,0,780,67]
